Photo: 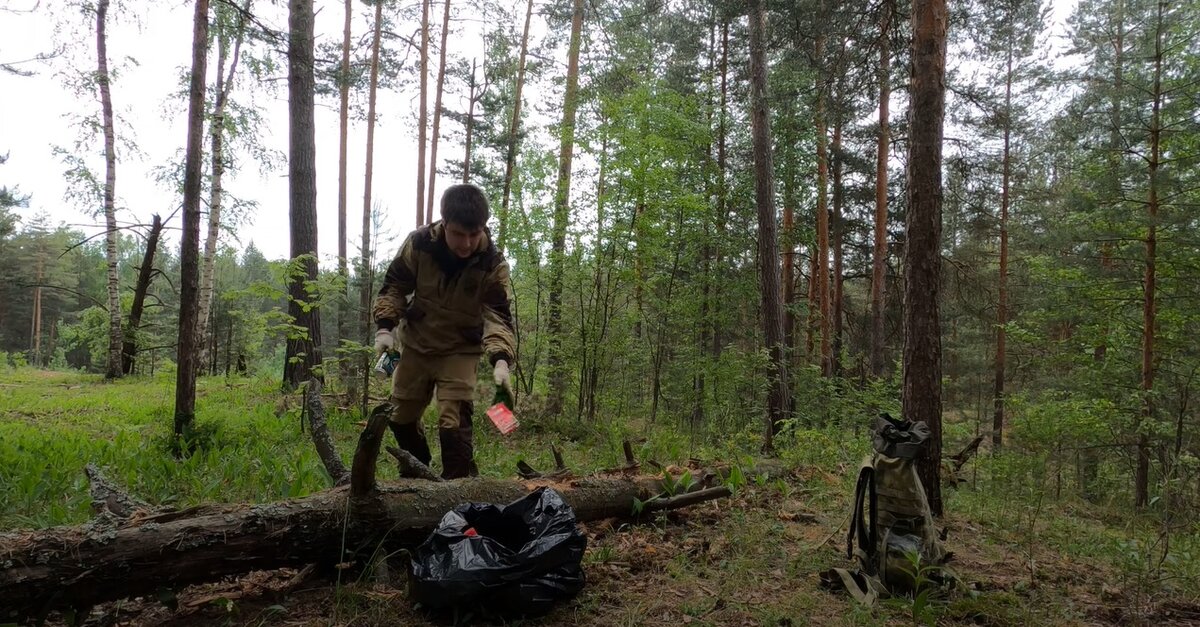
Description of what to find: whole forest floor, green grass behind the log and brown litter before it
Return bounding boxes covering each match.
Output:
[0,370,1200,626]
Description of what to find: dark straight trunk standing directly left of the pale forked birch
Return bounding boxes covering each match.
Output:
[175,0,209,438]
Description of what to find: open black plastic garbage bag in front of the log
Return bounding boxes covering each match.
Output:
[409,488,588,616]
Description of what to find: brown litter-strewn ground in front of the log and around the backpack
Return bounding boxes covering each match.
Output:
[60,478,1200,627]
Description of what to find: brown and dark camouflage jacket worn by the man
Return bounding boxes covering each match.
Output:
[374,221,516,364]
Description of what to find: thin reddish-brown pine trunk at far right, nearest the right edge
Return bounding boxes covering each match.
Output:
[1134,1,1166,509]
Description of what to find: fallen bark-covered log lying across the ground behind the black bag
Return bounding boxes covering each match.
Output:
[0,463,722,622]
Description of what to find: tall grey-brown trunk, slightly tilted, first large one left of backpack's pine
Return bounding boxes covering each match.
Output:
[748,0,791,449]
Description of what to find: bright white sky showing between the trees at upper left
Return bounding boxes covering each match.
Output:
[0,0,506,265]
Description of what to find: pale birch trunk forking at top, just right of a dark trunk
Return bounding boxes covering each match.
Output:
[196,1,250,370]
